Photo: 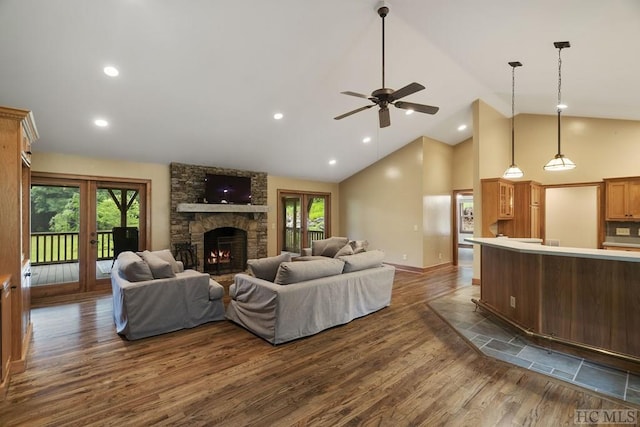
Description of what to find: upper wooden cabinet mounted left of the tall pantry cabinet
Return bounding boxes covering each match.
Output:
[482,178,514,237]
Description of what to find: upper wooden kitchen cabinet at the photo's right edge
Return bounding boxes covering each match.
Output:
[604,177,640,221]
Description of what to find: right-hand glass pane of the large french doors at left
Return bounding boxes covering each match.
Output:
[92,187,140,279]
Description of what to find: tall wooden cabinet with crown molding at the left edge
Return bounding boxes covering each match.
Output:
[0,107,38,390]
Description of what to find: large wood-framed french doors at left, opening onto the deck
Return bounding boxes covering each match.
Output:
[31,172,150,299]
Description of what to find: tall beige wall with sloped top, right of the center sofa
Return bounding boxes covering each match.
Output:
[340,137,454,268]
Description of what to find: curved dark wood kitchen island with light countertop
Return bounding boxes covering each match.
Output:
[465,237,640,370]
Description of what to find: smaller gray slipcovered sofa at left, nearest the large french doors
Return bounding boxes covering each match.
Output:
[111,250,224,340]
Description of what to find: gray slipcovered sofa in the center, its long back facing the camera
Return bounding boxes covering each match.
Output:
[226,251,395,344]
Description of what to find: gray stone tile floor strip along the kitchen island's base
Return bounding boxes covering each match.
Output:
[429,286,640,404]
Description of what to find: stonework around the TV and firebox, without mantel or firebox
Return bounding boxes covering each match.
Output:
[170,163,267,271]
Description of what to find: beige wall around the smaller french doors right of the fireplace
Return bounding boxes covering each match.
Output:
[267,175,340,256]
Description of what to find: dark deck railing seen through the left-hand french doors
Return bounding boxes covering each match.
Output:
[31,230,113,265]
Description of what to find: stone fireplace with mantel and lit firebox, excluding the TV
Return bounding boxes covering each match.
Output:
[170,163,268,276]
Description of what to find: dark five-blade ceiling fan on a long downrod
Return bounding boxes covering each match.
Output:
[334,2,439,128]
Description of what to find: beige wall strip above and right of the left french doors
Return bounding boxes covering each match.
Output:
[31,151,170,250]
